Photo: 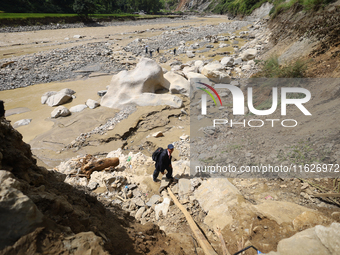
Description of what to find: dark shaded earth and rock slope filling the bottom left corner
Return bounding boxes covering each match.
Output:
[0,118,181,254]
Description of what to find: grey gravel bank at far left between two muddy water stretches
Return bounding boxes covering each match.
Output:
[0,42,125,91]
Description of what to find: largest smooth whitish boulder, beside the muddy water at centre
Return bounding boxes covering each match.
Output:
[101,58,182,108]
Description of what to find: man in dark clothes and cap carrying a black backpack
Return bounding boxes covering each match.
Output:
[153,144,174,182]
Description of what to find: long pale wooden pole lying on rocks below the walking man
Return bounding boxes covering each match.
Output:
[168,188,217,255]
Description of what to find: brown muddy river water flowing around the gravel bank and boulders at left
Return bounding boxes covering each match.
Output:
[0,16,239,167]
